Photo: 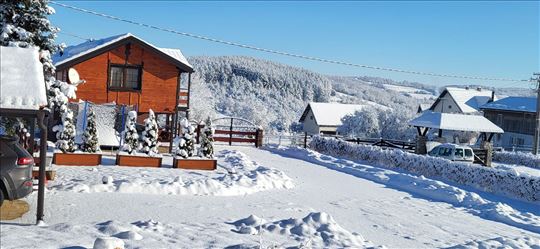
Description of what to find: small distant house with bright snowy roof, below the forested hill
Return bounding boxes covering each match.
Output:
[299,102,365,135]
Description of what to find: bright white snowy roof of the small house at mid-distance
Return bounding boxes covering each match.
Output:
[300,102,366,126]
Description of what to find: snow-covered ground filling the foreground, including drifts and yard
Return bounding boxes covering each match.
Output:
[0,145,540,248]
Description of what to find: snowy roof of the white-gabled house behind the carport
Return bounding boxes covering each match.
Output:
[433,87,493,113]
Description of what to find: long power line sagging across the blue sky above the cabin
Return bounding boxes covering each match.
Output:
[50,1,529,82]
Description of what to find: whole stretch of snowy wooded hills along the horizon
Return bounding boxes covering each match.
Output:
[189,56,532,131]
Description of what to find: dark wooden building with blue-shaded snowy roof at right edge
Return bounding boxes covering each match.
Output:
[480,97,537,150]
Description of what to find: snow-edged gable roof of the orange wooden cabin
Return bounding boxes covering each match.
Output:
[52,33,193,69]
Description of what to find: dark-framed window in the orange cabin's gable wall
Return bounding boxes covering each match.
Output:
[109,65,142,91]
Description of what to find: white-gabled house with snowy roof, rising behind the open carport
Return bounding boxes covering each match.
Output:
[429,87,495,114]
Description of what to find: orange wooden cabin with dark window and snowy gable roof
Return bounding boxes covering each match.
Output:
[53,33,194,140]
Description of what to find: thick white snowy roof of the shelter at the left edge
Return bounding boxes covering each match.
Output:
[0,46,47,110]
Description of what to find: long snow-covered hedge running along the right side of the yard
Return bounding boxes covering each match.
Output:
[310,136,540,202]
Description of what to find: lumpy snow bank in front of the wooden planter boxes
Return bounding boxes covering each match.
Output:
[50,151,294,196]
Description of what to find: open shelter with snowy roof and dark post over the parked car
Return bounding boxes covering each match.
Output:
[0,46,49,223]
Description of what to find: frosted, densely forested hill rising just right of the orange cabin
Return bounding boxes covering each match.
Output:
[189,56,332,130]
